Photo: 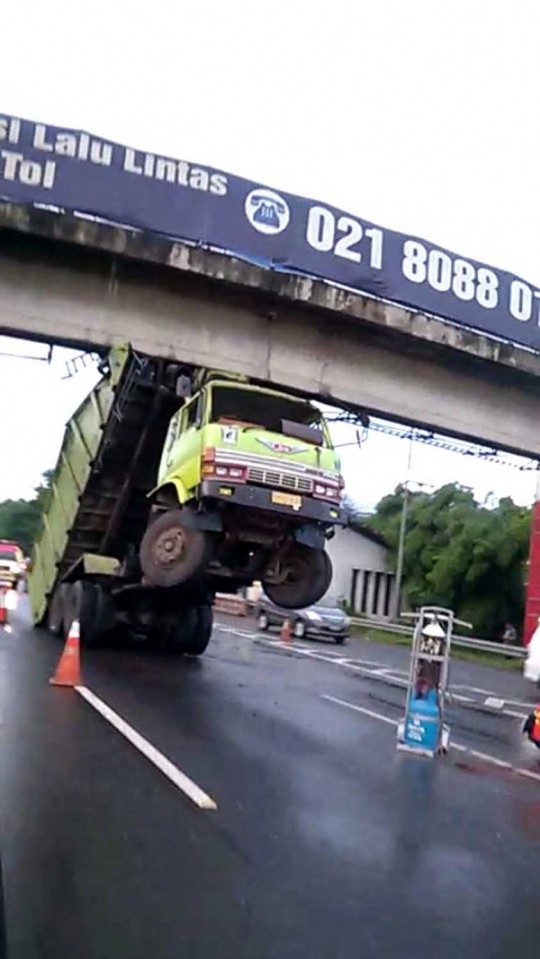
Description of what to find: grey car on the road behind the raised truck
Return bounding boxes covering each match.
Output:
[257,593,351,643]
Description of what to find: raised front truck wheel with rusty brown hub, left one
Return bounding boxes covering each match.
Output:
[139,509,211,587]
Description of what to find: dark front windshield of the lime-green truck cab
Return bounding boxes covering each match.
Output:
[210,386,326,445]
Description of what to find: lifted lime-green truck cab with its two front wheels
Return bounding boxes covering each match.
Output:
[140,374,343,608]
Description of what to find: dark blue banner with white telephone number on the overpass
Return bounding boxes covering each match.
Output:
[0,115,540,349]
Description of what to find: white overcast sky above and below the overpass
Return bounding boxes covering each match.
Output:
[0,0,540,506]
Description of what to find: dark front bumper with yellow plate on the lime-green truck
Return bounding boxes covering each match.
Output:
[200,479,344,526]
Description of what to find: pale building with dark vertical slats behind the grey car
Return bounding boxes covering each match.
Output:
[327,521,395,619]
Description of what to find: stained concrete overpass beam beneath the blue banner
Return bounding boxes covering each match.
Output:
[0,201,540,458]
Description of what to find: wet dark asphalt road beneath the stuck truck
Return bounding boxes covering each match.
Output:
[0,612,540,959]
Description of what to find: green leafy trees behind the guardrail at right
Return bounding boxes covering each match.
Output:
[368,483,531,639]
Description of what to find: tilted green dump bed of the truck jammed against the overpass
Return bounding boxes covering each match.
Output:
[29,347,179,622]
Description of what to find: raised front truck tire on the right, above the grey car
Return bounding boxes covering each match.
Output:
[263,543,332,609]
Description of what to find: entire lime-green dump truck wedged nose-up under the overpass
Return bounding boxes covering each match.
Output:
[29,347,343,655]
